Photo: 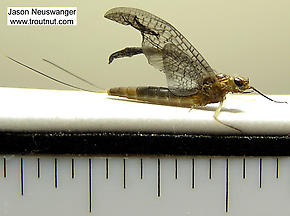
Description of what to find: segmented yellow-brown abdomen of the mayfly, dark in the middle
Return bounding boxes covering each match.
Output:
[107,86,194,107]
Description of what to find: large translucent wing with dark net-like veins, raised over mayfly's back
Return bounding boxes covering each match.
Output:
[105,7,215,96]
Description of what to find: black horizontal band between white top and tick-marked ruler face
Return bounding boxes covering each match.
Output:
[0,132,290,156]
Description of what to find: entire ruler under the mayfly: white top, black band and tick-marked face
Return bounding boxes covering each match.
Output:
[0,88,290,215]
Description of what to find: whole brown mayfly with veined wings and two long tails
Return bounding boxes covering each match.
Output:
[8,7,287,130]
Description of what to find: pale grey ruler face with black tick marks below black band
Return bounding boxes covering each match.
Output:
[0,155,290,216]
